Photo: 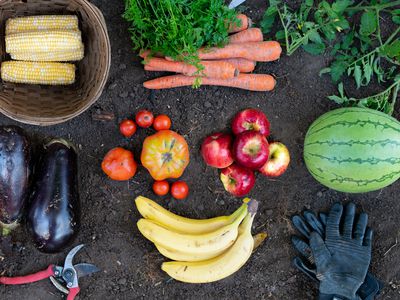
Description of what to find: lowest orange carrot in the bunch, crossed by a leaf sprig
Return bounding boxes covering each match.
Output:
[143,74,276,92]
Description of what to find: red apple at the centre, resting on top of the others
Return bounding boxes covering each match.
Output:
[233,131,269,170]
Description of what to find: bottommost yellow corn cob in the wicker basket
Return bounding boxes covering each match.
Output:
[1,61,75,85]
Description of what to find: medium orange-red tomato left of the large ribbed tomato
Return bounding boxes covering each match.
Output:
[101,147,137,180]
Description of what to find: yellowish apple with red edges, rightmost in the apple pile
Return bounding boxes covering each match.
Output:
[259,142,290,177]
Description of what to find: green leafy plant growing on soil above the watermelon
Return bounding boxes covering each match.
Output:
[261,0,400,114]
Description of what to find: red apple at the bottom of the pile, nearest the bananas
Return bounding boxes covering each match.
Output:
[220,164,256,197]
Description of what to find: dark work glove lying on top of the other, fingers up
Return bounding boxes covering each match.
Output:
[295,203,372,299]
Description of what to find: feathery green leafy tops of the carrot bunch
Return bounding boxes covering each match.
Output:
[123,0,237,70]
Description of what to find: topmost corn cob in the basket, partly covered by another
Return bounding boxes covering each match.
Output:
[6,15,78,35]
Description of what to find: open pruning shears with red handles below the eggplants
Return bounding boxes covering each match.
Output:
[0,244,100,300]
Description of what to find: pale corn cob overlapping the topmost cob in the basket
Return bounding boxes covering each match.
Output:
[6,30,82,53]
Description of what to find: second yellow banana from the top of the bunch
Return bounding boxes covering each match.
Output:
[137,207,247,254]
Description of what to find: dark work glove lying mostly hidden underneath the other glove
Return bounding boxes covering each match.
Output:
[292,210,384,300]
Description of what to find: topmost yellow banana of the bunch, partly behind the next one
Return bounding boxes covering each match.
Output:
[135,196,247,234]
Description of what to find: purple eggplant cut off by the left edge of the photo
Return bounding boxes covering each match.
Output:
[0,126,32,234]
